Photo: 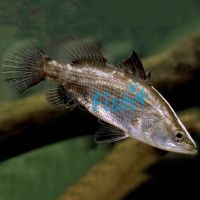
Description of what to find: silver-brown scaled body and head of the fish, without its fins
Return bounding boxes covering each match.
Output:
[44,61,197,154]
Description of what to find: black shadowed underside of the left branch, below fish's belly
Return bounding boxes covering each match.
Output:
[0,108,99,161]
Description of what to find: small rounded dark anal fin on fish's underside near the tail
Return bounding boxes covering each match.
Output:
[46,84,77,110]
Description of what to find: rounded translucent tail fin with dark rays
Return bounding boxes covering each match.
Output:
[1,41,50,94]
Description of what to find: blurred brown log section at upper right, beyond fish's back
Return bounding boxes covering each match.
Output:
[144,33,200,90]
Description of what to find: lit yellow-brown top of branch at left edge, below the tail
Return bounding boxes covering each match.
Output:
[0,95,53,138]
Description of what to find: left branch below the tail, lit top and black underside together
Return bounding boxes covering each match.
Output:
[0,95,98,161]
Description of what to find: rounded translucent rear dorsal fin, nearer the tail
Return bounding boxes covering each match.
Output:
[66,42,107,65]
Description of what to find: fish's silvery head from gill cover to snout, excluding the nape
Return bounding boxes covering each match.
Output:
[145,112,197,154]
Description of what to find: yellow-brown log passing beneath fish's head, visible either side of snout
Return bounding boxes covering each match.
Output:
[59,109,200,200]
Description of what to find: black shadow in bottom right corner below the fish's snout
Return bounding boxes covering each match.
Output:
[124,136,200,200]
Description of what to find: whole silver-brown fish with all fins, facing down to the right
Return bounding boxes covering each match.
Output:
[1,41,197,154]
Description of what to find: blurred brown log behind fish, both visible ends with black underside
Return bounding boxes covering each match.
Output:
[0,31,200,160]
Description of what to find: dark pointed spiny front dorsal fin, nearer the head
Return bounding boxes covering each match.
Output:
[122,51,150,83]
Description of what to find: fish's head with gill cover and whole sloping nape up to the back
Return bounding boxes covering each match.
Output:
[140,88,197,154]
